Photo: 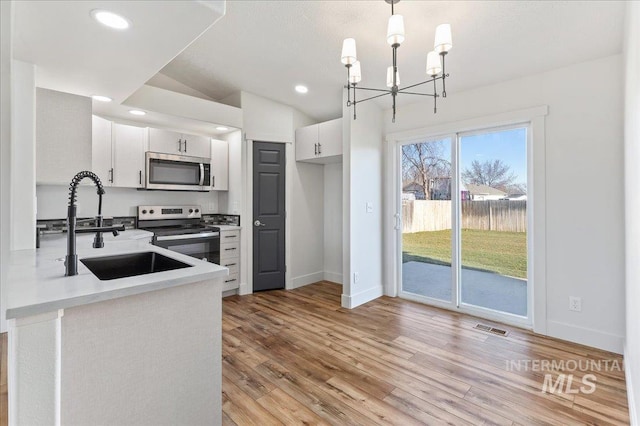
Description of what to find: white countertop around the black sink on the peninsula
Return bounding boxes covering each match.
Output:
[6,231,230,319]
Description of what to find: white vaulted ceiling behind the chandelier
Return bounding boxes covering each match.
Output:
[161,0,625,120]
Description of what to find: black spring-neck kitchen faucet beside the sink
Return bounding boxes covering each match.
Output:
[64,171,124,276]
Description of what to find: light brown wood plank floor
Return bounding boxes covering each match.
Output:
[0,282,629,426]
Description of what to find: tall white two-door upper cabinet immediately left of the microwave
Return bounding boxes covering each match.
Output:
[91,115,146,188]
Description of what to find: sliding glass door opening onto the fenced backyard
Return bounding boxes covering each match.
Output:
[399,125,530,319]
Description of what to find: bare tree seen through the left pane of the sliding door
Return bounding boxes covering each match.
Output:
[402,141,451,199]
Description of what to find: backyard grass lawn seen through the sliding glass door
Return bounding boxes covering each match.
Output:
[402,229,527,279]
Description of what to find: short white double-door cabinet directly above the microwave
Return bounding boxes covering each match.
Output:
[149,128,211,158]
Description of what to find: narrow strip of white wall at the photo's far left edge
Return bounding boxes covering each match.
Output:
[0,1,13,333]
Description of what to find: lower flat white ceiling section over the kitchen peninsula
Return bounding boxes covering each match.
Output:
[13,0,225,104]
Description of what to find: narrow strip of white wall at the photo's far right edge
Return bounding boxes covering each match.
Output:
[624,2,640,424]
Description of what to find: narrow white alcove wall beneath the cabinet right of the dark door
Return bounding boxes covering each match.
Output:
[324,163,342,284]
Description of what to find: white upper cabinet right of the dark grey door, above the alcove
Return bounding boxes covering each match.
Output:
[296,118,342,164]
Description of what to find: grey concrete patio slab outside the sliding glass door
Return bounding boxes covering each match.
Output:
[402,262,527,316]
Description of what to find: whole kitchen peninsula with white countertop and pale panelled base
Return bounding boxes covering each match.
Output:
[7,230,228,425]
